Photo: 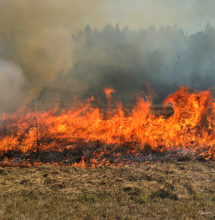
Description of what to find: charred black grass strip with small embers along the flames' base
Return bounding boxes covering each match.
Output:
[0,141,209,168]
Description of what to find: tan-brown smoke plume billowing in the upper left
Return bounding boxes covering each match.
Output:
[0,0,106,99]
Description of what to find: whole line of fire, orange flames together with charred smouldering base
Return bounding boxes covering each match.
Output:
[0,86,215,168]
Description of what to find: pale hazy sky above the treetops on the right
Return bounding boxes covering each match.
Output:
[107,0,215,32]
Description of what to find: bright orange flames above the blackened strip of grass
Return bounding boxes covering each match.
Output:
[0,87,215,167]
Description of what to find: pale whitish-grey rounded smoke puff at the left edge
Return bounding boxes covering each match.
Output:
[0,60,25,113]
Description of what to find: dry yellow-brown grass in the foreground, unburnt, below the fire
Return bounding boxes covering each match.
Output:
[0,160,215,219]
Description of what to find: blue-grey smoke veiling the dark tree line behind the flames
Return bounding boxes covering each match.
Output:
[40,24,215,102]
